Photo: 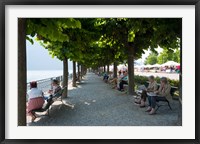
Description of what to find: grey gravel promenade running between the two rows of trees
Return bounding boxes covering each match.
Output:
[28,73,179,126]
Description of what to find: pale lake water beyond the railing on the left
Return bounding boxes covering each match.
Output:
[27,70,72,82]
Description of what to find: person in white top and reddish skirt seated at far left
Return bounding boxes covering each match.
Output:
[27,81,45,122]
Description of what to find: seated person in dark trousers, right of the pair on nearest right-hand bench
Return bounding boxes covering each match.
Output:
[146,77,171,115]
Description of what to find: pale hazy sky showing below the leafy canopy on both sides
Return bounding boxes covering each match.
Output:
[26,38,162,70]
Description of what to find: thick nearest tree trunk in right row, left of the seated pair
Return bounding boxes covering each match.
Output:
[128,43,134,95]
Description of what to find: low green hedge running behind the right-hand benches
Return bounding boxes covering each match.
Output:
[134,75,179,87]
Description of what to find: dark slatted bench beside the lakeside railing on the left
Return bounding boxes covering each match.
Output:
[31,86,66,116]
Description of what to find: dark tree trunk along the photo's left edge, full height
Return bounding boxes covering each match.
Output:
[18,18,27,126]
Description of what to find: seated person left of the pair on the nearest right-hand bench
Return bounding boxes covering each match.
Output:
[135,75,158,108]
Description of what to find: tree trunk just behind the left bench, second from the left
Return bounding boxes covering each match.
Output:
[62,58,68,98]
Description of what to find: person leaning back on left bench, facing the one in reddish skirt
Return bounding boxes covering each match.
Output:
[44,79,61,101]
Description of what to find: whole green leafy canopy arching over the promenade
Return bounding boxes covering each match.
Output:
[27,18,181,68]
